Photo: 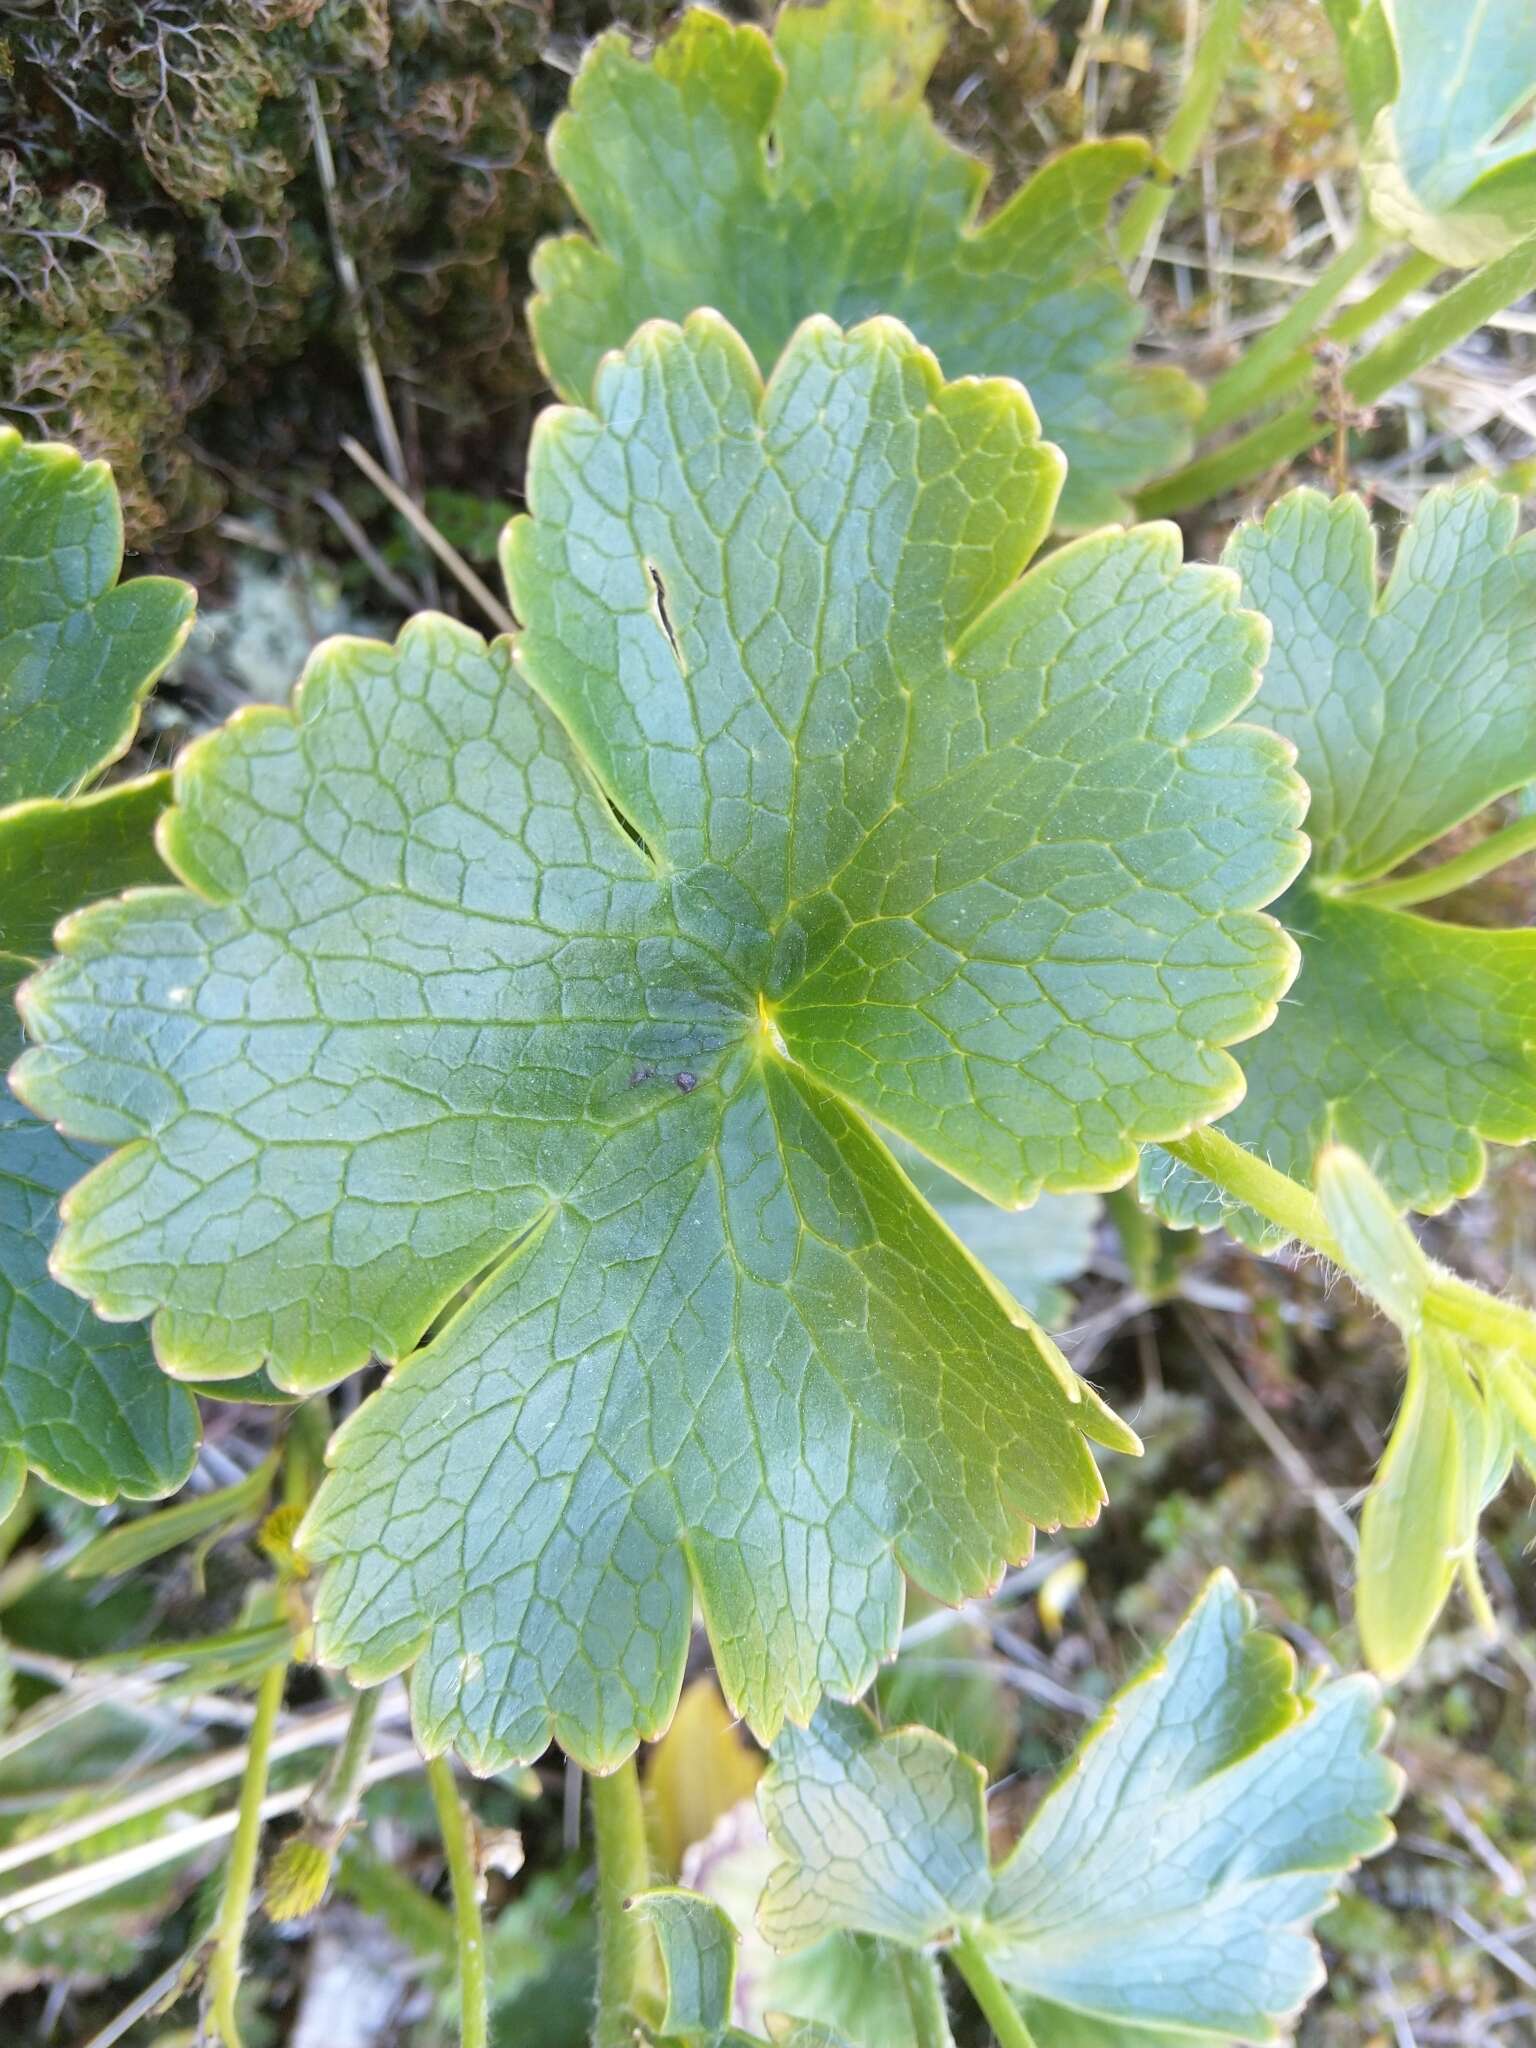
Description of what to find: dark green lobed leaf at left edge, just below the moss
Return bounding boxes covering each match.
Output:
[0,426,195,803]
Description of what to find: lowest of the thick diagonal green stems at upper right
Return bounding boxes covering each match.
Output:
[1137,236,1536,518]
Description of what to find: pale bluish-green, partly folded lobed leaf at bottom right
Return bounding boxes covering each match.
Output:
[758,1573,1399,2048]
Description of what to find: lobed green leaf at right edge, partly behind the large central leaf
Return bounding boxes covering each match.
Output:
[1143,485,1536,1237]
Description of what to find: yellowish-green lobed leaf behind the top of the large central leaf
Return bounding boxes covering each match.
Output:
[528,0,1198,530]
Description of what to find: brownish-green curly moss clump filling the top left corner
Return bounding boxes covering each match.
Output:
[0,0,563,543]
